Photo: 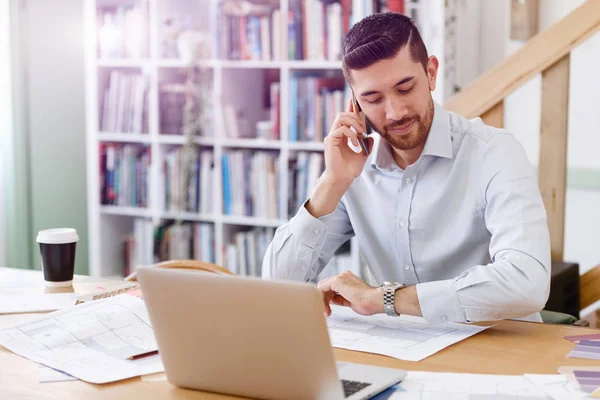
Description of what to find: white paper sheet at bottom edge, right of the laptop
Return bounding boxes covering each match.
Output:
[373,371,576,400]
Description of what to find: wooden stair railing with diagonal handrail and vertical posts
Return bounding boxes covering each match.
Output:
[445,0,600,318]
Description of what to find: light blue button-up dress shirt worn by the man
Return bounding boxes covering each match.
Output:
[263,103,551,324]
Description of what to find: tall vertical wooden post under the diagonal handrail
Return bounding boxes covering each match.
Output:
[539,54,570,261]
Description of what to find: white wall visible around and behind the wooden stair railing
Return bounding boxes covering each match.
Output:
[457,0,600,273]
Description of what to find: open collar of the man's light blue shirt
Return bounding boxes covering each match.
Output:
[371,101,454,171]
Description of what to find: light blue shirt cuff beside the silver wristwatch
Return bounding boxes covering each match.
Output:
[417,279,467,324]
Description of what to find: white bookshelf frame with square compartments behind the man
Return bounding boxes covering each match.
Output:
[85,0,450,276]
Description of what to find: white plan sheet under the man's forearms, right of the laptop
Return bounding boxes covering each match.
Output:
[327,306,488,361]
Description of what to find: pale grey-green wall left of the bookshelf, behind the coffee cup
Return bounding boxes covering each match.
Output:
[9,0,88,273]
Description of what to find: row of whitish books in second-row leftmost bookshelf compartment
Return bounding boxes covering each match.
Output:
[100,69,148,133]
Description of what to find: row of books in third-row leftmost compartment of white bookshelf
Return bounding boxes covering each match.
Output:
[99,143,150,207]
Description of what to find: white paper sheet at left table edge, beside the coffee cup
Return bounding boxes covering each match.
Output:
[0,293,77,314]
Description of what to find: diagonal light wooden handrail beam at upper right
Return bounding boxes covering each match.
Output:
[445,0,600,118]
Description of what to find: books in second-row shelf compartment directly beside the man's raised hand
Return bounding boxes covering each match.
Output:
[289,76,346,142]
